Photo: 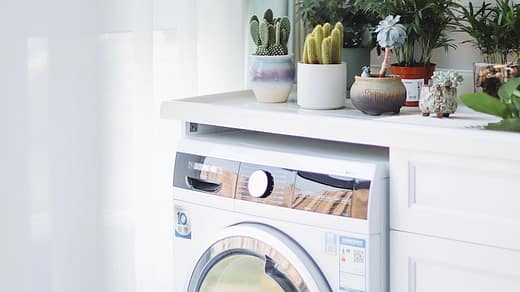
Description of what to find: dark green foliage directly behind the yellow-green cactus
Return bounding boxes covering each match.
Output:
[296,0,377,49]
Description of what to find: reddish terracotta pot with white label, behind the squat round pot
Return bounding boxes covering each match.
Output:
[392,64,435,106]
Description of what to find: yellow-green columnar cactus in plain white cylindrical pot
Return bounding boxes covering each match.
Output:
[298,22,347,109]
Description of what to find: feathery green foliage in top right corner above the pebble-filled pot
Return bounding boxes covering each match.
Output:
[454,0,520,64]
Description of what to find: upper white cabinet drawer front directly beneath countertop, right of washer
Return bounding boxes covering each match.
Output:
[390,149,520,249]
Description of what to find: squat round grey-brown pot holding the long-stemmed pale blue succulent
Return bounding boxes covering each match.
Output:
[350,75,406,115]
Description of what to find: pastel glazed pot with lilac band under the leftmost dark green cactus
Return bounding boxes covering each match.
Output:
[249,55,294,103]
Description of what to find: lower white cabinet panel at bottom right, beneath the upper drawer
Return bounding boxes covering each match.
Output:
[390,231,520,292]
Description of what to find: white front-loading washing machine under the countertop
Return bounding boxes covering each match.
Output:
[174,131,388,292]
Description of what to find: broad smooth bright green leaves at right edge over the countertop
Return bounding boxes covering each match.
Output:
[460,78,520,132]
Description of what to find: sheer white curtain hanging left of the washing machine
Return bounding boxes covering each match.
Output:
[0,0,247,292]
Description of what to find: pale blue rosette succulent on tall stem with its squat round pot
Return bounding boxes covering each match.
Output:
[350,15,406,115]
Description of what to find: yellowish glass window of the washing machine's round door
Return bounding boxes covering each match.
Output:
[200,254,284,292]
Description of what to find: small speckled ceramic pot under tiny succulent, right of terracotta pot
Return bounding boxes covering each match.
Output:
[419,85,457,118]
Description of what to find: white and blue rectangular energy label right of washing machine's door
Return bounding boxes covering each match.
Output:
[339,236,366,292]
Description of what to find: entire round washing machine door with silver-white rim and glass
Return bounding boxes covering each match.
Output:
[188,223,332,292]
